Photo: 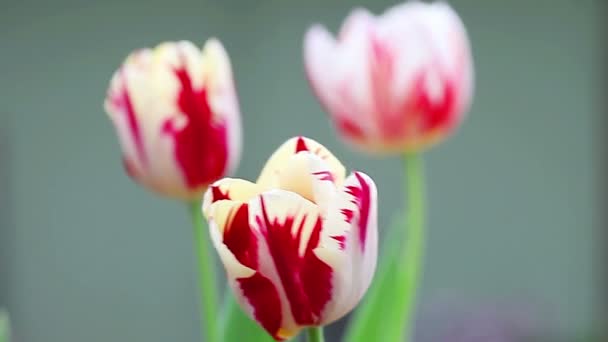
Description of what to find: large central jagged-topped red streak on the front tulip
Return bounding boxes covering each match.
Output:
[256,197,332,325]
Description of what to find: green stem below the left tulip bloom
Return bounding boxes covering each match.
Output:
[189,201,219,342]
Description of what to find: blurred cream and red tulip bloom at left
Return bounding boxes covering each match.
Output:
[105,39,241,200]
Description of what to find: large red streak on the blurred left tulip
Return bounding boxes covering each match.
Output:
[163,62,228,188]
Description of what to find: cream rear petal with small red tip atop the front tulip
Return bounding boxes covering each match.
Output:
[256,137,345,189]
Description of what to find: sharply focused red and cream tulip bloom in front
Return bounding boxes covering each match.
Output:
[202,137,378,340]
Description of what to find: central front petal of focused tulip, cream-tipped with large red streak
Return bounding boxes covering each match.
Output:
[250,190,333,331]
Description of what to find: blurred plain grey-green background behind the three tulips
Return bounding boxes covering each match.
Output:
[0,0,606,342]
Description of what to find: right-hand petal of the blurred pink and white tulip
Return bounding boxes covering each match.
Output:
[377,2,473,150]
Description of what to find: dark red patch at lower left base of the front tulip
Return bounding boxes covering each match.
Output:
[237,273,282,341]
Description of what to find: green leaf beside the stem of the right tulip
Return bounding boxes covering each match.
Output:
[343,215,405,342]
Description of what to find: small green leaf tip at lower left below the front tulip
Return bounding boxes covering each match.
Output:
[221,291,274,342]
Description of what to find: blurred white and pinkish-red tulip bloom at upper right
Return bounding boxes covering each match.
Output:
[304,1,473,153]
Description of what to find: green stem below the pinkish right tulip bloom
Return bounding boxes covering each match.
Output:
[398,153,426,342]
